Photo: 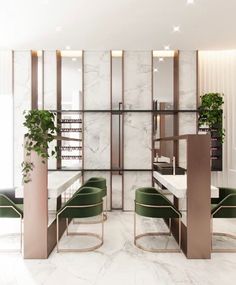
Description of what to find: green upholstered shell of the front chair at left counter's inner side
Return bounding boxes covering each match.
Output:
[58,187,103,218]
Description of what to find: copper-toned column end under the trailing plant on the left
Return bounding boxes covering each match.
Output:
[24,149,48,259]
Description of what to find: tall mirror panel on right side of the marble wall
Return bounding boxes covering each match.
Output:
[153,51,174,160]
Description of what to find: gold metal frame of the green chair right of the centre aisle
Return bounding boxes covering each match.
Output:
[134,201,181,253]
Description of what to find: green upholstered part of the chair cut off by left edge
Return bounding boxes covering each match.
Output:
[0,194,23,218]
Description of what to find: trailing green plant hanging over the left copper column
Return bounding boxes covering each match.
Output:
[21,110,59,183]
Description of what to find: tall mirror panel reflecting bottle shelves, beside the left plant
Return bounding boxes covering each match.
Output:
[60,51,82,169]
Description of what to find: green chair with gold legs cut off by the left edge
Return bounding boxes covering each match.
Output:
[0,189,23,252]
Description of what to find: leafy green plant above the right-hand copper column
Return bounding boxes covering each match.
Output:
[198,93,225,143]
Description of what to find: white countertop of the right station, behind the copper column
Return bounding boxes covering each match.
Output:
[153,171,219,198]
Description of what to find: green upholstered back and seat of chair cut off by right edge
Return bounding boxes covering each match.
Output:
[211,187,236,218]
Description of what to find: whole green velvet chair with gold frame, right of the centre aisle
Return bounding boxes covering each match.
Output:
[134,187,181,252]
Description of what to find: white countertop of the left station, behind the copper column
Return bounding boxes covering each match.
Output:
[16,171,82,199]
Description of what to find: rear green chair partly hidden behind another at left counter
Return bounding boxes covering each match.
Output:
[75,177,107,223]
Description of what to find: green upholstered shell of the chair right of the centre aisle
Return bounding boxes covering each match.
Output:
[135,187,181,218]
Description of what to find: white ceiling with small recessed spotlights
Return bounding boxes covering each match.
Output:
[0,0,236,50]
